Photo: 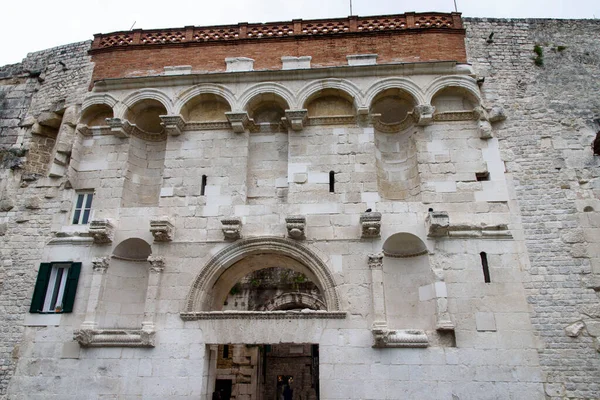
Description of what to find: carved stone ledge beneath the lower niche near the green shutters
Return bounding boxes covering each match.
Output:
[73,329,155,347]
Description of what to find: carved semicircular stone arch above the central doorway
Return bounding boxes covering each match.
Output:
[184,237,340,313]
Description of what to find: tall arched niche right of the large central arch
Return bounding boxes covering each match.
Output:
[383,232,436,331]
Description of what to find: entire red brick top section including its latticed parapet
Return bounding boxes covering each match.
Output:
[90,13,466,81]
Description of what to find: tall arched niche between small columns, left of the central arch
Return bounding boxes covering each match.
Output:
[97,238,152,329]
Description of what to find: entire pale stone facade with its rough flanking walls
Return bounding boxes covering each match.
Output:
[0,14,600,400]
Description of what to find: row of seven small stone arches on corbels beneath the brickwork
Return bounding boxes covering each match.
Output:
[78,75,487,140]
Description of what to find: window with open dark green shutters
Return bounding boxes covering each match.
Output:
[29,262,81,313]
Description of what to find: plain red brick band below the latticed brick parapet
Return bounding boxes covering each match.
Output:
[92,29,466,81]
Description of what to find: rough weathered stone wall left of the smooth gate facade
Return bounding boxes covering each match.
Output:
[0,42,93,400]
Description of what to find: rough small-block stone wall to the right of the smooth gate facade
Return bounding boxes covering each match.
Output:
[465,19,600,399]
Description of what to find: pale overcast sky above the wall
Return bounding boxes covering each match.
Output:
[0,0,600,65]
